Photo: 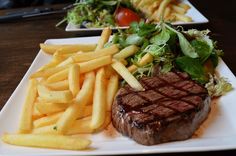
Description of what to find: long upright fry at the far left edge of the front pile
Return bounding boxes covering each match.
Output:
[19,79,37,133]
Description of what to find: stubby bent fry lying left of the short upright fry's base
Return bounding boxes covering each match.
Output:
[38,85,73,103]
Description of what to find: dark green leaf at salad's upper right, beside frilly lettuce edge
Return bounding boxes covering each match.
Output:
[191,39,212,63]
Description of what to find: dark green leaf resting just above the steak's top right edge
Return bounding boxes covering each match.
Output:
[175,56,207,83]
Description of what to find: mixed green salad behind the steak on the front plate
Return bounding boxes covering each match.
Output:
[109,22,232,96]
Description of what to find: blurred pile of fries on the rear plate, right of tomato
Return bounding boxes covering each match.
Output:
[131,0,192,22]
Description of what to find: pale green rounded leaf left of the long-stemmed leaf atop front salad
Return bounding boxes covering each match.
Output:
[150,29,170,45]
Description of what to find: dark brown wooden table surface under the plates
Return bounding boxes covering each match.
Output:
[0,0,236,156]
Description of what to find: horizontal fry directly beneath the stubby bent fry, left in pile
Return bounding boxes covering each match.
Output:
[35,102,69,114]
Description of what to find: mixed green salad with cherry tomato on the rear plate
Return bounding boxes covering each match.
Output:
[57,0,140,28]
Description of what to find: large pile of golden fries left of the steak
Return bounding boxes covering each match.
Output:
[2,28,144,150]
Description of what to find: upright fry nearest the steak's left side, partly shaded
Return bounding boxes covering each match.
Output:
[106,75,119,111]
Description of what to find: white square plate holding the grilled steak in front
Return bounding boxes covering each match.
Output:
[0,37,236,156]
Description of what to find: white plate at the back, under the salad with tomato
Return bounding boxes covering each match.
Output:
[65,0,209,32]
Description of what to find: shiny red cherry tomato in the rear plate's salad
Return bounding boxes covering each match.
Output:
[115,7,141,26]
